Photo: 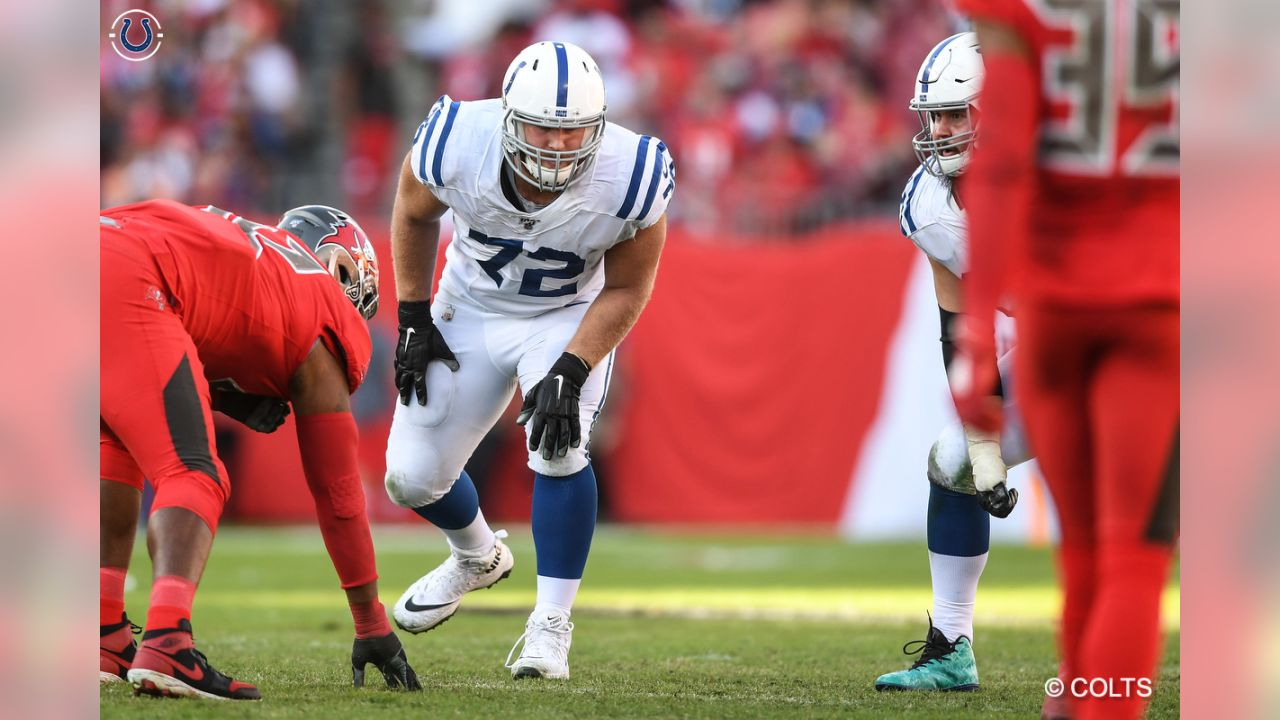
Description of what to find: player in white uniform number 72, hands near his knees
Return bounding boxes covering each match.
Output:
[387,42,676,678]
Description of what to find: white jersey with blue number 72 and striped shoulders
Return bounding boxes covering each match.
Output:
[411,95,676,318]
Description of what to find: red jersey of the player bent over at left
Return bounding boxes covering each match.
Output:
[101,200,372,400]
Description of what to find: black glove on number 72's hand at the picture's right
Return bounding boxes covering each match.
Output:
[516,352,591,460]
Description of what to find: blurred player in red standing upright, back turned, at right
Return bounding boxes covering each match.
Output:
[952,0,1179,717]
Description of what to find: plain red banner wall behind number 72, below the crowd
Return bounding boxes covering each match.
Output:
[228,219,913,523]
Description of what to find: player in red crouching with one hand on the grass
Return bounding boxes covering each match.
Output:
[100,200,419,700]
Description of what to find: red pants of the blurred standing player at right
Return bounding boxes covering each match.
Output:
[1016,304,1179,719]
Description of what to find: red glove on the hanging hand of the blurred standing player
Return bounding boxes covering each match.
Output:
[947,315,1005,432]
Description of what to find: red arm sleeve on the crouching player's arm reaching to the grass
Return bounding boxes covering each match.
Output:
[297,413,378,589]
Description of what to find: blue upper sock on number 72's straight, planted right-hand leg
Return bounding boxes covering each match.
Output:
[532,465,596,580]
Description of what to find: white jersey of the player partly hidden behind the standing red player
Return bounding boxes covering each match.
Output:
[897,165,969,277]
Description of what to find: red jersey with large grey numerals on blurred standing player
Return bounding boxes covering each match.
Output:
[959,0,1179,305]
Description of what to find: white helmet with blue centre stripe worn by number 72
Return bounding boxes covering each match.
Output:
[502,42,605,192]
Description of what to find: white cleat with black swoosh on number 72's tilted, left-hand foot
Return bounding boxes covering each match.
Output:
[392,530,516,633]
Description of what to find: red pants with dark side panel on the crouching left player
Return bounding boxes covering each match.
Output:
[100,225,230,530]
